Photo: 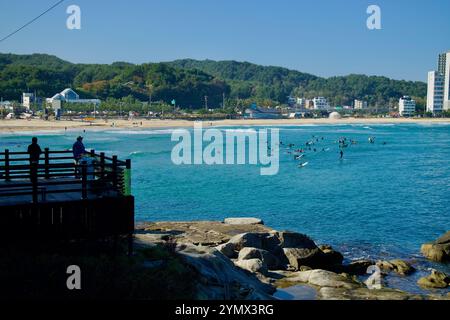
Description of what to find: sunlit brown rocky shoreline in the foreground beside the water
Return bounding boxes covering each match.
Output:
[135,218,450,300]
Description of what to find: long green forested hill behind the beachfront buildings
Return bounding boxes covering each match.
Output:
[0,53,426,108]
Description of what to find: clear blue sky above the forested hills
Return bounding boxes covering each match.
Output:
[0,0,450,81]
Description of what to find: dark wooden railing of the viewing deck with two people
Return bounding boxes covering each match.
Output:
[0,148,131,203]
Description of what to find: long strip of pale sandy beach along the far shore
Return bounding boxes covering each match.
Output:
[0,118,450,133]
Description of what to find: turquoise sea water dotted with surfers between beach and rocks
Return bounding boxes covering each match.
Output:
[0,124,450,296]
